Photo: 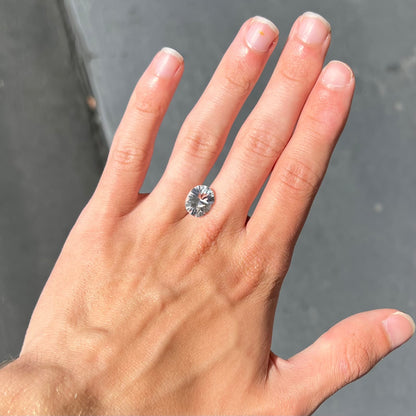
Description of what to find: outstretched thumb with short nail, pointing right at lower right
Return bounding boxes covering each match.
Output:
[268,309,415,414]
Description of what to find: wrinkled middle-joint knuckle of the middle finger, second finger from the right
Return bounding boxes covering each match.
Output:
[244,123,281,159]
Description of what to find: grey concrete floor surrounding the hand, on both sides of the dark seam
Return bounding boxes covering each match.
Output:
[0,0,416,416]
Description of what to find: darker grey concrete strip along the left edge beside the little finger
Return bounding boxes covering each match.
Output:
[0,0,101,362]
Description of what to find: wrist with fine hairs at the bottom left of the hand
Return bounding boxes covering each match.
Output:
[0,358,92,415]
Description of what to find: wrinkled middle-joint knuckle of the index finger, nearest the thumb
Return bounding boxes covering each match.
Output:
[279,160,321,198]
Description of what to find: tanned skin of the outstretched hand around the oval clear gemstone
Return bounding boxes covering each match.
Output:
[0,13,413,415]
